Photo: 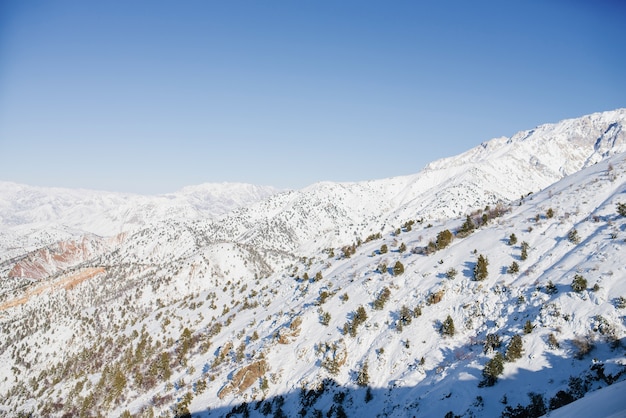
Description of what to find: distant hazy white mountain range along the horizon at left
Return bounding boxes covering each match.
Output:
[0,182,279,261]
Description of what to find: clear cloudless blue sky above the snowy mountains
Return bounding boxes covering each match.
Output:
[0,0,626,194]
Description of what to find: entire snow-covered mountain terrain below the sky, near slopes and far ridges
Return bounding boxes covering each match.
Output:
[0,110,626,417]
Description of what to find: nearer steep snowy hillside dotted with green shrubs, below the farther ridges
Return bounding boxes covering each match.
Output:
[0,154,626,416]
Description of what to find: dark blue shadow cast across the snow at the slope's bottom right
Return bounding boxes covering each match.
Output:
[184,338,626,418]
